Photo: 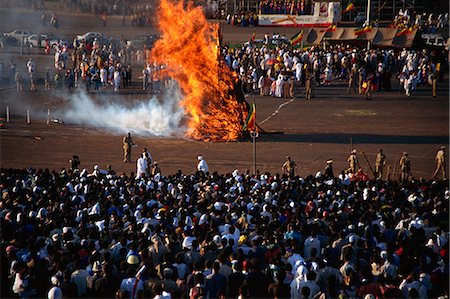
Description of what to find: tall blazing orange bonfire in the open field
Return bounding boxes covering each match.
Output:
[150,0,247,141]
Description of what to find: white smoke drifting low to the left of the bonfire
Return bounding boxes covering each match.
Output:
[62,87,185,137]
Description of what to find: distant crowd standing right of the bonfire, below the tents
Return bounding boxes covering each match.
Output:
[223,33,448,97]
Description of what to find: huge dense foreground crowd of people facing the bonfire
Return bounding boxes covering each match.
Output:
[0,145,450,299]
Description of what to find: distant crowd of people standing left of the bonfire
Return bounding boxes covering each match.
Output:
[0,33,159,92]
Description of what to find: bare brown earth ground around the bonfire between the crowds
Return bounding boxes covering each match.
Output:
[0,9,449,178]
